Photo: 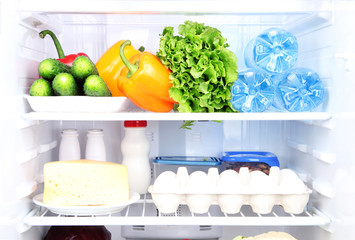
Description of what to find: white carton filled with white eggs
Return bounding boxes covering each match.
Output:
[148,167,312,214]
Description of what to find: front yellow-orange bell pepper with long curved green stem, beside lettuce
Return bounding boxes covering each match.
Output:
[118,40,176,112]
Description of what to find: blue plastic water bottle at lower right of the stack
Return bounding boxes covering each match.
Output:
[272,68,326,112]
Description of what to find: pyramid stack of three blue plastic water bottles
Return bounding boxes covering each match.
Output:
[231,28,325,112]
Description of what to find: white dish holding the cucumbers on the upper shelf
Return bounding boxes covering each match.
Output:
[25,95,133,113]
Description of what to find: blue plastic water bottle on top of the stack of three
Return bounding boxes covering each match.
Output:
[244,28,298,73]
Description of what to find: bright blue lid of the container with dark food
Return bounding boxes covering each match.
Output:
[221,151,280,167]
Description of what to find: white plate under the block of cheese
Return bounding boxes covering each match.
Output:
[33,192,140,216]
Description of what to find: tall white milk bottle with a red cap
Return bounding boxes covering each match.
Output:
[121,121,151,194]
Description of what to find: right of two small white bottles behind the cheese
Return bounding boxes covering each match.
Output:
[85,129,106,161]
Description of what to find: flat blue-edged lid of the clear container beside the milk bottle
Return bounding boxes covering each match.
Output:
[153,156,221,166]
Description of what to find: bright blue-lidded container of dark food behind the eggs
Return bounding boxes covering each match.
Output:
[221,151,280,175]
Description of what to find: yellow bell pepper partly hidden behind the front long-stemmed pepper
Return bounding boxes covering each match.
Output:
[96,40,144,97]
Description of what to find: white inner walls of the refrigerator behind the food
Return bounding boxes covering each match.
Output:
[0,1,355,240]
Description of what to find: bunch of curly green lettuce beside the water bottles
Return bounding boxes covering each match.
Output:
[157,21,238,112]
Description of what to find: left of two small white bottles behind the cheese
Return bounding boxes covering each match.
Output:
[59,128,81,161]
